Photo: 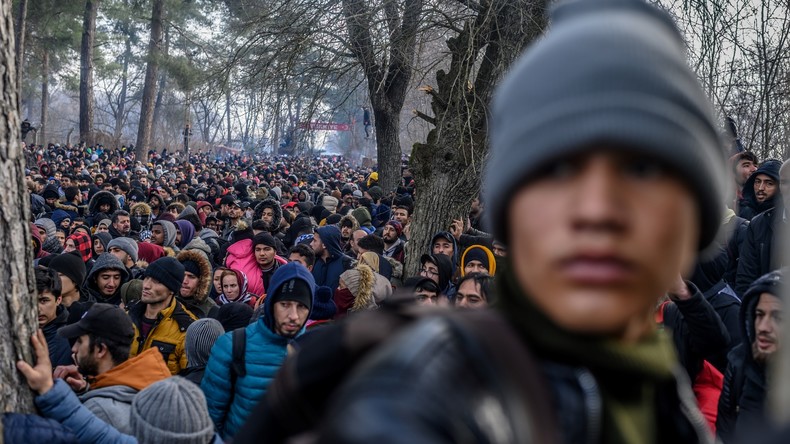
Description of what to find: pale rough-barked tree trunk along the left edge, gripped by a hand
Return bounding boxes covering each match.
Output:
[0,0,37,413]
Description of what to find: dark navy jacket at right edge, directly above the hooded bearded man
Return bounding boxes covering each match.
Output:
[734,206,783,295]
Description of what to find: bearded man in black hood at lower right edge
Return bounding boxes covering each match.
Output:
[716,269,786,444]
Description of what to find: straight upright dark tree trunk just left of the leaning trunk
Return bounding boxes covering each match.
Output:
[80,0,99,146]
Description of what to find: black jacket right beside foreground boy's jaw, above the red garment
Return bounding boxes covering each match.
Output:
[663,283,730,381]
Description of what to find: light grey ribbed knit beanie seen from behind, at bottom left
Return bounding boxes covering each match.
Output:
[129,376,214,444]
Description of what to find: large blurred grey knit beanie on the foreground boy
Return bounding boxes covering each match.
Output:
[484,0,728,249]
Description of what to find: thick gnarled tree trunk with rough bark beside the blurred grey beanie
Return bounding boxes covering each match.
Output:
[404,0,546,276]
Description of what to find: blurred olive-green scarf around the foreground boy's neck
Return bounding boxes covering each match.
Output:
[497,264,677,444]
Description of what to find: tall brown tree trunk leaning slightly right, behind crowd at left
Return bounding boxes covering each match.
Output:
[135,0,164,162]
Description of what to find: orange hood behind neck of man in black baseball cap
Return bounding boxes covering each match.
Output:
[91,347,171,391]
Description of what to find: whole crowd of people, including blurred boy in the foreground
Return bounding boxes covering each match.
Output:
[4,0,790,444]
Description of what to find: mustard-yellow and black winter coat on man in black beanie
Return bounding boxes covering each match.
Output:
[129,298,197,375]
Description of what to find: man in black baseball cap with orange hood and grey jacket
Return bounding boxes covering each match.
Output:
[54,303,170,434]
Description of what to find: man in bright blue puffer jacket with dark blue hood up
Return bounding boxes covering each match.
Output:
[200,263,316,440]
